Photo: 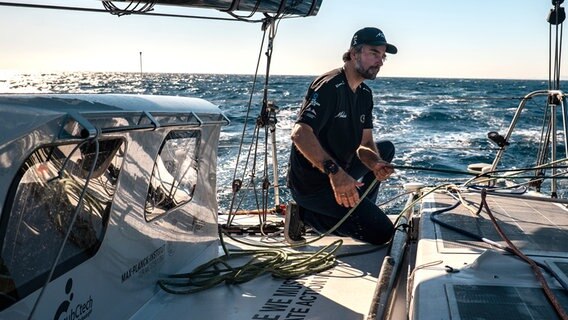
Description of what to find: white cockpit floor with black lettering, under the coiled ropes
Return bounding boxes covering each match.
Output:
[134,212,386,320]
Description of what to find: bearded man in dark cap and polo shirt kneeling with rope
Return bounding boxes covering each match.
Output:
[285,27,397,244]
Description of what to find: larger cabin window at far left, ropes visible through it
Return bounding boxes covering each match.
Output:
[0,139,124,310]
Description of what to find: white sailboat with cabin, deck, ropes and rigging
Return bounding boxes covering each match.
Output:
[0,0,568,320]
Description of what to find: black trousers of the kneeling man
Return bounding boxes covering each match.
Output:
[291,141,395,244]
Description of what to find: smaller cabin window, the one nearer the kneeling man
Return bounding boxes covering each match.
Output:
[145,130,201,222]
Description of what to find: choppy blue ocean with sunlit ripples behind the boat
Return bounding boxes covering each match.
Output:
[0,73,566,212]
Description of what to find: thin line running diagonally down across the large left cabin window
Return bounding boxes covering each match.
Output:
[28,136,101,320]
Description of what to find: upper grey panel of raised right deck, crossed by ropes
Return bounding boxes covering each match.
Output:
[428,193,568,257]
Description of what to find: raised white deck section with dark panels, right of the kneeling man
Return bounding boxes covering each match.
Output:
[410,193,568,319]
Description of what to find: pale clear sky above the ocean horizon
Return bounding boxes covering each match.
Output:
[0,0,568,79]
